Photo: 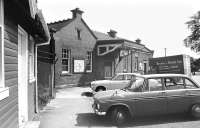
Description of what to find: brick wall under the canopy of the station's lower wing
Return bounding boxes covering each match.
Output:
[95,50,152,79]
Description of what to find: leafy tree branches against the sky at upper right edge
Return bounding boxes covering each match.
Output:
[184,11,200,52]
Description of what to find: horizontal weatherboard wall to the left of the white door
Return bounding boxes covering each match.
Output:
[0,10,18,128]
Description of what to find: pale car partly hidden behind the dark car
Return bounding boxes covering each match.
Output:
[91,73,140,92]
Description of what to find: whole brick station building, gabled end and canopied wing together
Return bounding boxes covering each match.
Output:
[48,8,153,85]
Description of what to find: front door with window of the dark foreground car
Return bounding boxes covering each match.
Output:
[133,78,167,116]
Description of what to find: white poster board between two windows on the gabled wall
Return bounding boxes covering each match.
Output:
[74,60,85,73]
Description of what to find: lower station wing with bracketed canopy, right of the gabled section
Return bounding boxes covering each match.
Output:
[94,30,153,79]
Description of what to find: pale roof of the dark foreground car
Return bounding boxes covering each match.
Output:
[142,74,188,78]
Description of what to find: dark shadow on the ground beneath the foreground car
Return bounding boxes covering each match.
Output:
[76,113,198,127]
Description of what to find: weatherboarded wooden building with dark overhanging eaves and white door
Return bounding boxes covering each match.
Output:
[0,0,49,128]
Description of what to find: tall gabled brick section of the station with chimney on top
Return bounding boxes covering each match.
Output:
[48,8,97,85]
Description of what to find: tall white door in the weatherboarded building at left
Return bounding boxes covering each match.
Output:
[18,26,28,127]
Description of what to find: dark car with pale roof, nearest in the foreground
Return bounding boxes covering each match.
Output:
[92,74,200,125]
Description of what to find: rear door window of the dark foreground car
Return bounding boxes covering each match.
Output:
[164,77,185,90]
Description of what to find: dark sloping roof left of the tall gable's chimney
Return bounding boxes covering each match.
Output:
[47,19,73,31]
